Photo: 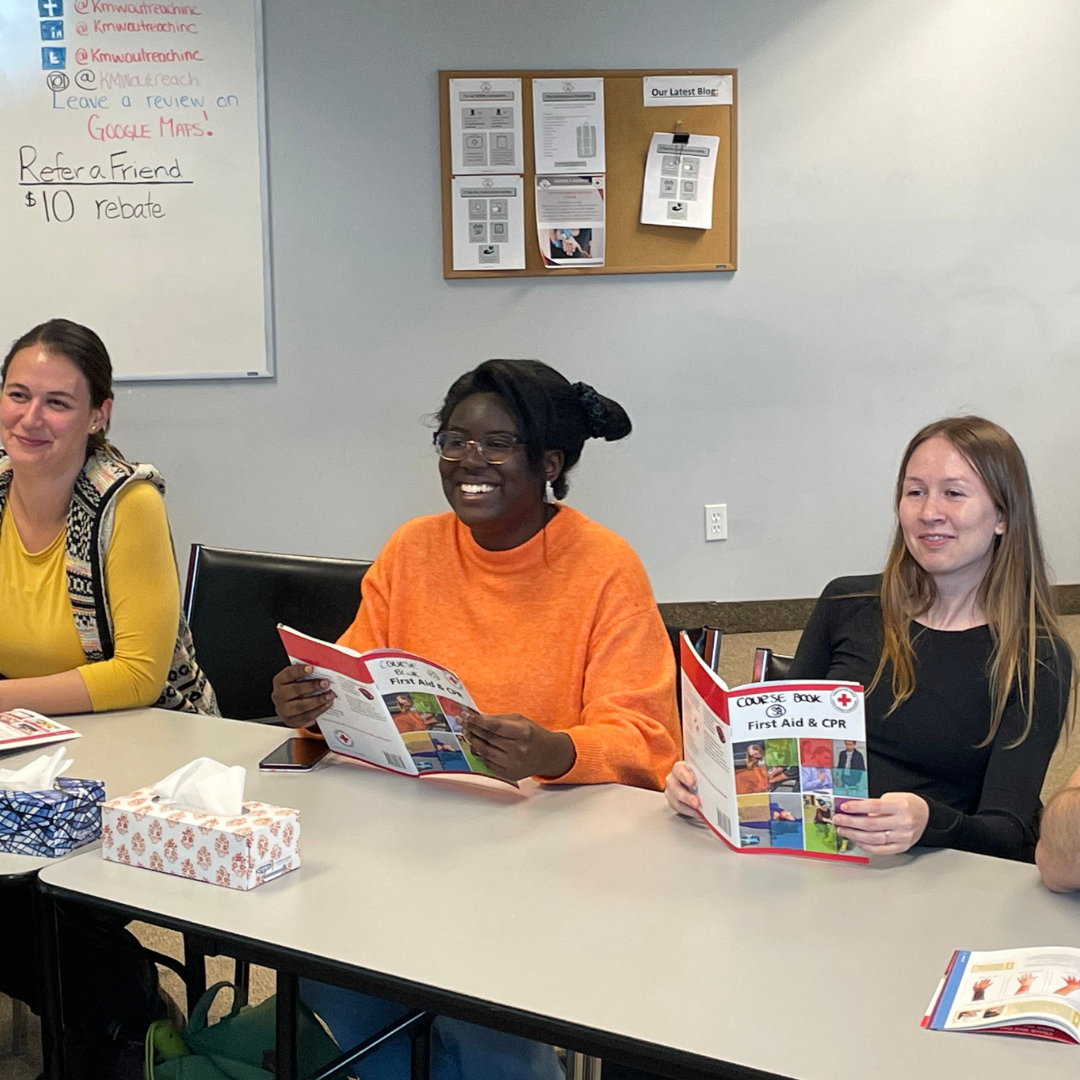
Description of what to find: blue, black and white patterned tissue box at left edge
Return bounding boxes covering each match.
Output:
[0,777,105,859]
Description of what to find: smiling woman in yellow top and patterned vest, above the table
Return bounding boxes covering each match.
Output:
[0,319,217,714]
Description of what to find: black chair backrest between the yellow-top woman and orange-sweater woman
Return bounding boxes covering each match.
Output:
[184,544,372,720]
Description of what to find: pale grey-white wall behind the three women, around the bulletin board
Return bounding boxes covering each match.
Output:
[107,0,1080,600]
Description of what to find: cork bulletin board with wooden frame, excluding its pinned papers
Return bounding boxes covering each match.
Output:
[438,68,739,278]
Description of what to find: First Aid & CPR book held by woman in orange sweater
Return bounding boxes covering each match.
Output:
[278,624,517,787]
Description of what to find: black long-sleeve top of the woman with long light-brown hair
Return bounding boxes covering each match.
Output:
[791,575,1071,862]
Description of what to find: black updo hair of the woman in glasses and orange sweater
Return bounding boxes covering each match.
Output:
[436,360,632,499]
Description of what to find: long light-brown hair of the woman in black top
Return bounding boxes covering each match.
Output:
[869,416,1075,746]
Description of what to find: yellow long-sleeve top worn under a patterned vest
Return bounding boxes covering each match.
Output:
[0,482,180,713]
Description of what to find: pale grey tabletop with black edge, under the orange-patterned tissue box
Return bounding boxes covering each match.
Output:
[40,716,1080,1080]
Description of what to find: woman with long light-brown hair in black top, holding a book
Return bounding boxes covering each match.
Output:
[667,417,1072,860]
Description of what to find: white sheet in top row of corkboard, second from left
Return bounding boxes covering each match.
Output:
[532,79,607,174]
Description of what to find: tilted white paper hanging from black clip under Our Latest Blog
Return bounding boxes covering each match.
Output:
[642,132,720,229]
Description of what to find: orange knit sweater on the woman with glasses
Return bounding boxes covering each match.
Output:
[339,505,680,788]
